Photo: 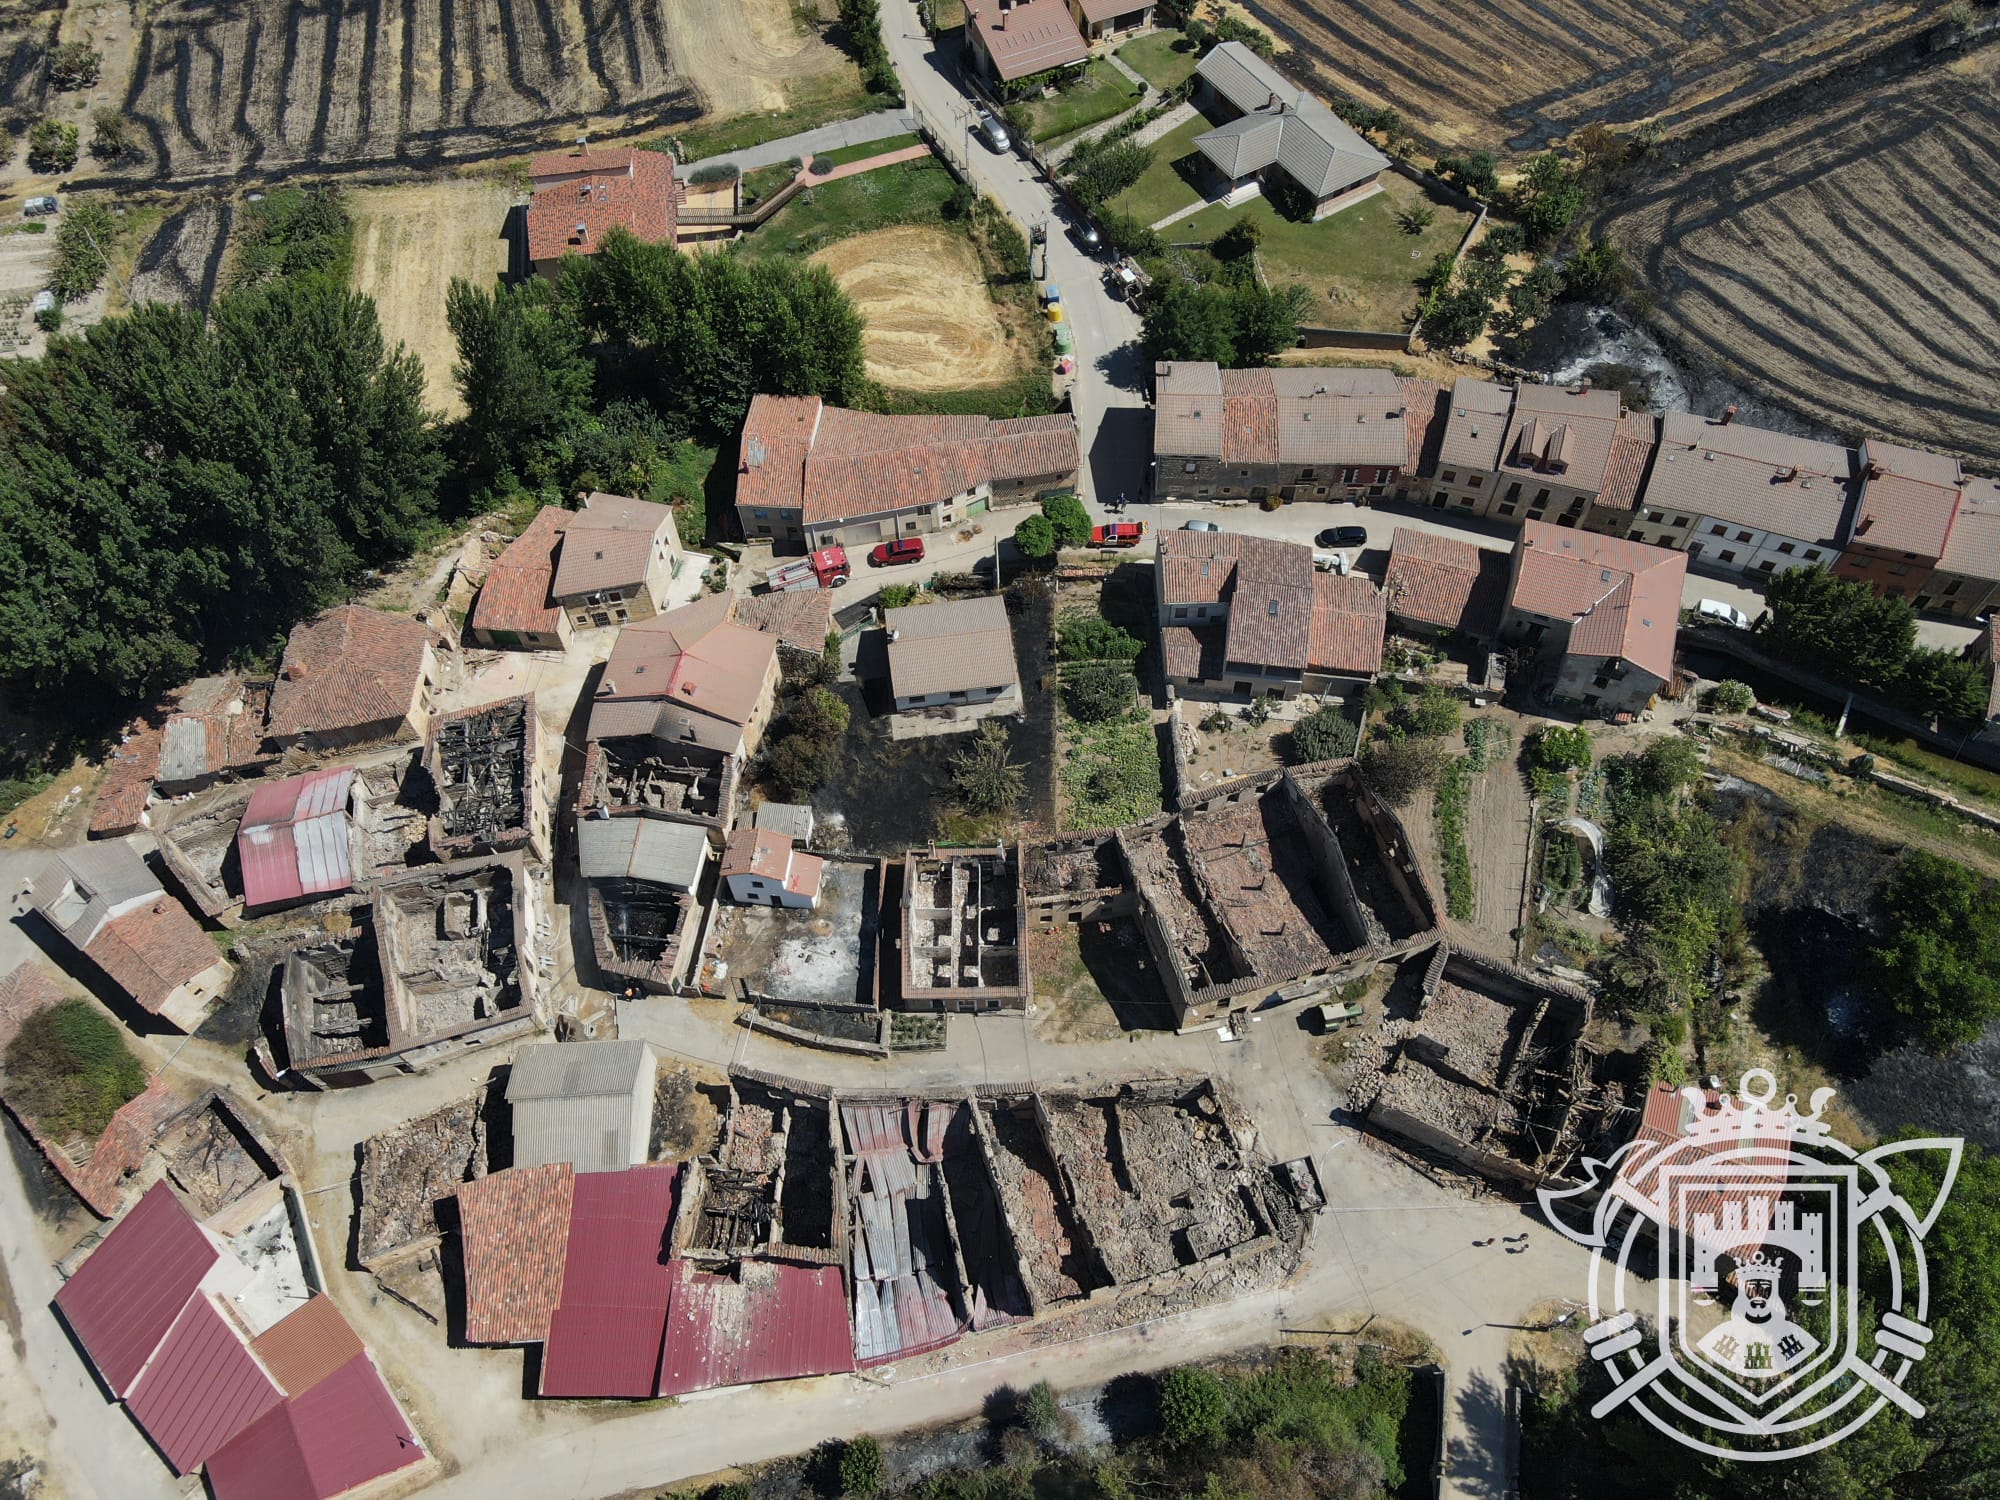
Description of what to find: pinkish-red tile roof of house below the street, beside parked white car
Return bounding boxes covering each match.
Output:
[1510,520,1688,682]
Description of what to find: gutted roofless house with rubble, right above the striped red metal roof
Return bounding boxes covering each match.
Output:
[676,1078,840,1264]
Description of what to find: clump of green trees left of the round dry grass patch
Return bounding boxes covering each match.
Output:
[446,230,866,500]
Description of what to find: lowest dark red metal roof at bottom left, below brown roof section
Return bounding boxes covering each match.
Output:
[208,1354,424,1500]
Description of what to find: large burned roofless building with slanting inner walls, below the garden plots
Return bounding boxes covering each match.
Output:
[1118,762,1436,1026]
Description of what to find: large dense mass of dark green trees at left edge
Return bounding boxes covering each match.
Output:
[0,194,446,714]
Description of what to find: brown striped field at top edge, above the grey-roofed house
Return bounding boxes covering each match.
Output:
[1248,0,1934,150]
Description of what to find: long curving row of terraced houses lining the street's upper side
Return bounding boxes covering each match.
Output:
[1154,362,2000,618]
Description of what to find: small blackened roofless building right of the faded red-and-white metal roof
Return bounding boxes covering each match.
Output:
[424,698,548,860]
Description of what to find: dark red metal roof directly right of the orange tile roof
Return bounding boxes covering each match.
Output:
[542,1164,680,1396]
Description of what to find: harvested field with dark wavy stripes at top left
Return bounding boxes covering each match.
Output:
[103,0,856,182]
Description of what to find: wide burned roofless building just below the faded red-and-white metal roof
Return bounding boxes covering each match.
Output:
[282,854,546,1086]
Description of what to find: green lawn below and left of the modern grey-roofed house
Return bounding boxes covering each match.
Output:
[1168,172,1472,330]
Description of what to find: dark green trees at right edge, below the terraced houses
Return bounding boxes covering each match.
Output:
[1758,566,1986,722]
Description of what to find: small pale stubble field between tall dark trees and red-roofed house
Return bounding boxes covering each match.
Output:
[348,178,518,416]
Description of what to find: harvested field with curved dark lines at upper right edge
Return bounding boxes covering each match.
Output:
[1608,46,2000,464]
